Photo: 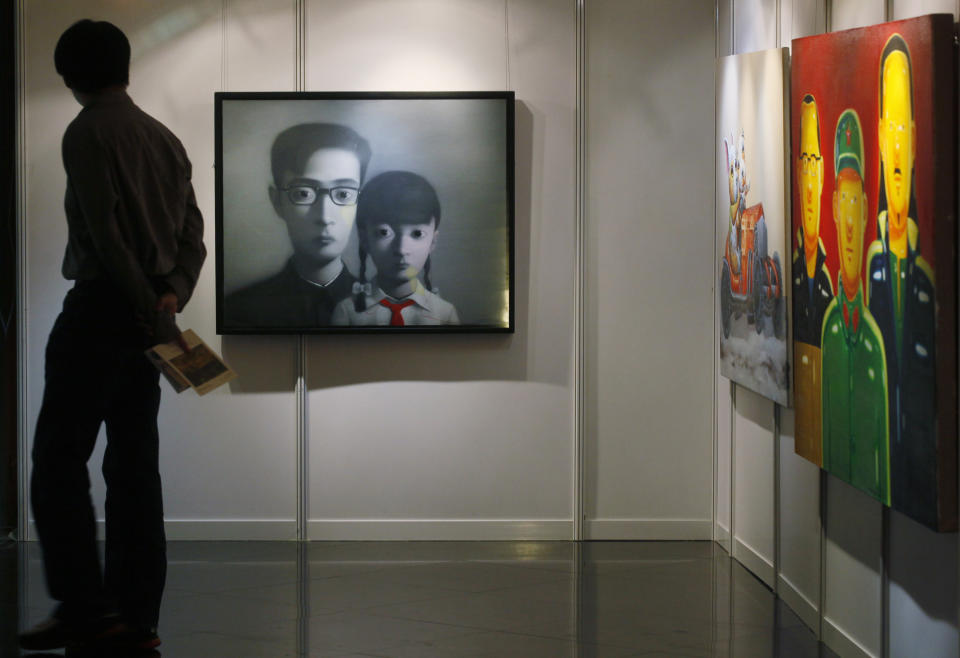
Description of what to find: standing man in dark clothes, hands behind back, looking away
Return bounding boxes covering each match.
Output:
[20,20,206,649]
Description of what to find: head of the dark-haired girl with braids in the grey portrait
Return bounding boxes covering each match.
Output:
[357,171,440,298]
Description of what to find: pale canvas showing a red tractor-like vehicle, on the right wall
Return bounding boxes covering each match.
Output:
[716,48,791,406]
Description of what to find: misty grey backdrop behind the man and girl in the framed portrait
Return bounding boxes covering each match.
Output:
[222,99,512,327]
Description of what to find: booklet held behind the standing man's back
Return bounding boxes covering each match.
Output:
[146,329,237,395]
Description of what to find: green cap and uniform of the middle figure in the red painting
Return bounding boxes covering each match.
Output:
[820,109,890,505]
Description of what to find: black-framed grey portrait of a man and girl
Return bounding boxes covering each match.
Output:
[215,91,515,334]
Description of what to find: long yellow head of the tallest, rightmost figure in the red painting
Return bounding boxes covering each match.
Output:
[877,34,917,258]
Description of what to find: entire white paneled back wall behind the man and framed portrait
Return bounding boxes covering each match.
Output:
[19,0,715,539]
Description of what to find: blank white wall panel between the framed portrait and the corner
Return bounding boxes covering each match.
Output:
[583,0,714,539]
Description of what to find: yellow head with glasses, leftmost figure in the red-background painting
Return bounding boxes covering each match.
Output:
[797,94,823,278]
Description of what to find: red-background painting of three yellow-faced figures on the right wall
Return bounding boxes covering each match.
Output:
[790,15,957,530]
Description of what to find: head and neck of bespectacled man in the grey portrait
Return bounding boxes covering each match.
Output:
[269,123,370,284]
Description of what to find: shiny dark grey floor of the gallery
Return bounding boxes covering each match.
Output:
[0,542,834,658]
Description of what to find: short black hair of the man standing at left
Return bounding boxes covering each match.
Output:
[53,18,130,93]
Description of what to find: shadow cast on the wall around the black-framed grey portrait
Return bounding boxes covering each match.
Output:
[222,102,536,393]
